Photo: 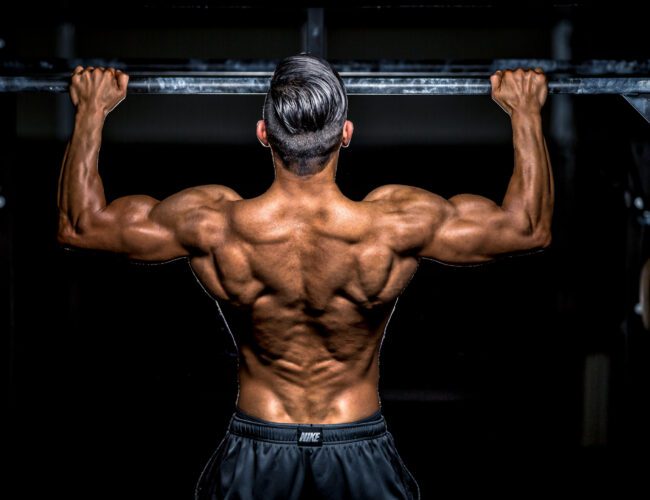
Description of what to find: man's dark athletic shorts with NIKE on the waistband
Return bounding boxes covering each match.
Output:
[195,410,420,500]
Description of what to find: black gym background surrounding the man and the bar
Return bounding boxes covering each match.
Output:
[0,2,650,499]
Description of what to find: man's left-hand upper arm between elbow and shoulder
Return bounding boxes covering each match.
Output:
[76,196,188,261]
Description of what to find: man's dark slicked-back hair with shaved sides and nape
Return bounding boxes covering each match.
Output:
[263,54,348,175]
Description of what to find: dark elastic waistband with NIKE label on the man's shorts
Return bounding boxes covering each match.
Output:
[228,409,387,446]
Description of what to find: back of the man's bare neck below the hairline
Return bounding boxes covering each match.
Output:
[271,152,340,196]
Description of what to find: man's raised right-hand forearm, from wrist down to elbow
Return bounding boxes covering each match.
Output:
[502,111,554,233]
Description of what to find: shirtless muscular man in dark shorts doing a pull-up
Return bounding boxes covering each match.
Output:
[58,55,554,500]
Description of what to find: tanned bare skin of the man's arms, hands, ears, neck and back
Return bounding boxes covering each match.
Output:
[58,67,554,424]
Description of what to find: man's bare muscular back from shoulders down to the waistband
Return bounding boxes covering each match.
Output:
[191,186,417,423]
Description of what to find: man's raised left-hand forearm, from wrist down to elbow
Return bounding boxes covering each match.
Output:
[58,108,106,232]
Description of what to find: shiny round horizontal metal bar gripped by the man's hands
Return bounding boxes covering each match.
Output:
[0,72,650,95]
